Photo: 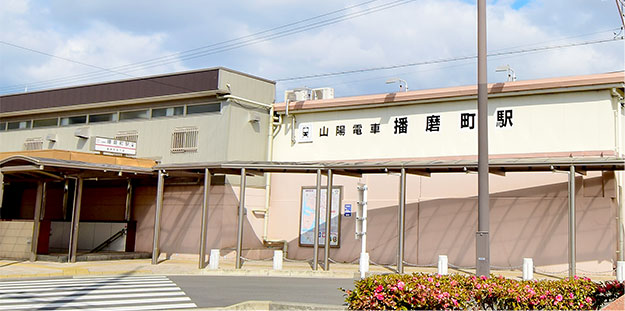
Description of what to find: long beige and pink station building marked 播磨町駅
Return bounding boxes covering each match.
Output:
[0,68,625,272]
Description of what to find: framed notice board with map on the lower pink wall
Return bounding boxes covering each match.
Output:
[299,186,343,247]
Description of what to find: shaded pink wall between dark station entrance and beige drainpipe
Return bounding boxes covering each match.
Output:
[132,183,262,254]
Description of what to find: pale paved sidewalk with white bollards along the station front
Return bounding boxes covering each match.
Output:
[0,255,615,281]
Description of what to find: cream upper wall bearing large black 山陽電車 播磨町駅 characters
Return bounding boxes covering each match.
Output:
[274,90,615,161]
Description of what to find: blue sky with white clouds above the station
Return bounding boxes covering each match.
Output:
[0,0,624,101]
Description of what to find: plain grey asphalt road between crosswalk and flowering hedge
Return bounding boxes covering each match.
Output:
[169,276,354,307]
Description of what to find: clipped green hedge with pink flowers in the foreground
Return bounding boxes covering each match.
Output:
[343,273,623,310]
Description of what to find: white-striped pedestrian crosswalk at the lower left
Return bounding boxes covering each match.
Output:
[0,276,197,311]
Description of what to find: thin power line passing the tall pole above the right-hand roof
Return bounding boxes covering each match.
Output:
[275,36,623,82]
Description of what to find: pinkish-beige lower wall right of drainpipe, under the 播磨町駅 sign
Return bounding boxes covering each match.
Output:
[269,173,616,270]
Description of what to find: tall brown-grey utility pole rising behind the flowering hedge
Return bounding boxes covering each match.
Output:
[475,0,490,276]
